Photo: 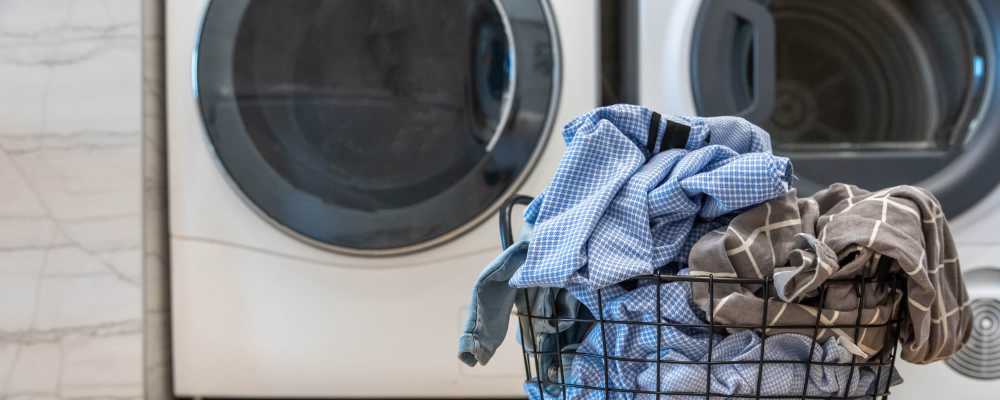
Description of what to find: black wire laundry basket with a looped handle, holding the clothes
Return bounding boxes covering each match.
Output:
[499,195,906,400]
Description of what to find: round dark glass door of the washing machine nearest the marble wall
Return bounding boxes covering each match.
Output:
[193,0,559,255]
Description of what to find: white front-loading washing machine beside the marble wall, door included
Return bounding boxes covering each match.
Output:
[166,0,599,398]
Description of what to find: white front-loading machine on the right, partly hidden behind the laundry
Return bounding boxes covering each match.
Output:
[621,0,1000,400]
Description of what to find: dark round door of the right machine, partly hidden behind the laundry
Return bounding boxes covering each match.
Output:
[692,0,1000,216]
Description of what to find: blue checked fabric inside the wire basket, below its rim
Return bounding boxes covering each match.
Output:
[525,276,898,399]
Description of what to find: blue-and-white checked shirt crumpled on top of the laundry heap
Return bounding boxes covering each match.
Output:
[510,105,792,294]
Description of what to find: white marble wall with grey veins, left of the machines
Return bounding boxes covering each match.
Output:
[0,0,143,399]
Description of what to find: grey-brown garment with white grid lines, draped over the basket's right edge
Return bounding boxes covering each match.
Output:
[688,184,971,363]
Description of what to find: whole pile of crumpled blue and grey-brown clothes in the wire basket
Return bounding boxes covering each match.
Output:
[459,105,971,399]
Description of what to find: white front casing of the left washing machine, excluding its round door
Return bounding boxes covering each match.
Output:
[166,0,599,397]
